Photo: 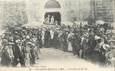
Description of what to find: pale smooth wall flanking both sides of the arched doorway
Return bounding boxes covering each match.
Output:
[26,0,90,21]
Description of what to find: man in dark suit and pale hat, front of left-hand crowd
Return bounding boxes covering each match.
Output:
[13,34,25,66]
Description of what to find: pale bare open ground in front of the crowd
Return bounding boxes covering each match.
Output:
[31,48,114,71]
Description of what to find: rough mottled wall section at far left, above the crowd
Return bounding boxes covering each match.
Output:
[0,0,28,28]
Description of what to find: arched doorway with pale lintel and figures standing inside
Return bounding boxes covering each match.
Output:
[44,0,61,25]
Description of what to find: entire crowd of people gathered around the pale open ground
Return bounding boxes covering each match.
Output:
[1,22,111,66]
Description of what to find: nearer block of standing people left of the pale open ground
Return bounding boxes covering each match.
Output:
[1,27,41,66]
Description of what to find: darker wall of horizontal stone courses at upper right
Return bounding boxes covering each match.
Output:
[91,0,114,22]
